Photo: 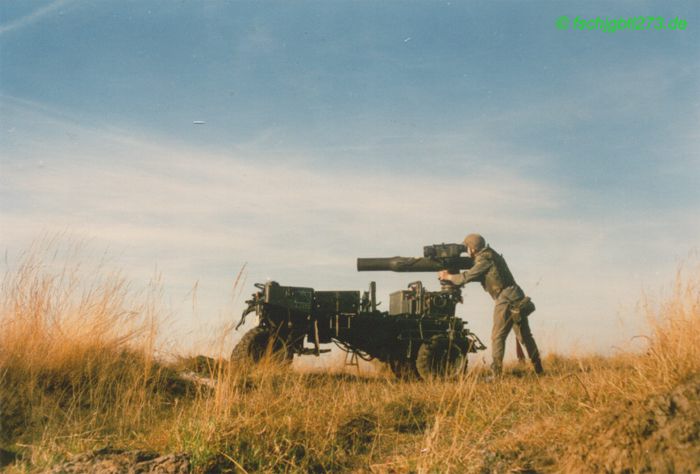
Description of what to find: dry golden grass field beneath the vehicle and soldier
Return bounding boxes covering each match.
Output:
[0,250,700,473]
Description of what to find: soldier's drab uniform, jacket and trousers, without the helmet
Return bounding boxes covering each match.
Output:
[453,246,542,374]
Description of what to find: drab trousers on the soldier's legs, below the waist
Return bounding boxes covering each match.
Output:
[491,285,540,374]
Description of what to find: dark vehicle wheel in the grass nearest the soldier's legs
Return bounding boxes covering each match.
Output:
[416,334,468,380]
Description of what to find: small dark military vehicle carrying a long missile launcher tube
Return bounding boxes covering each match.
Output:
[231,244,486,379]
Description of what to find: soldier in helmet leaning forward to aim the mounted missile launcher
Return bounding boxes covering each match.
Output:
[438,234,543,375]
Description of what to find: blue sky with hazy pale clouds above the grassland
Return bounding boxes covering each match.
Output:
[0,0,700,362]
